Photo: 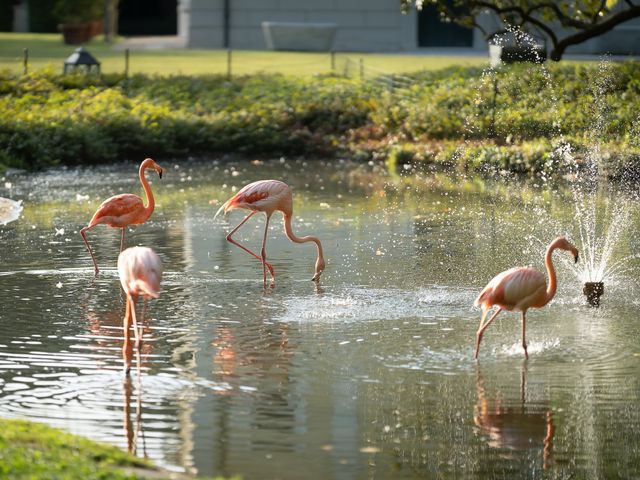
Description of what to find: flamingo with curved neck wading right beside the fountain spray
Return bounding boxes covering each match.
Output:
[473,237,578,359]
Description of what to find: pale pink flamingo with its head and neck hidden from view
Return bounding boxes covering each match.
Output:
[118,247,162,374]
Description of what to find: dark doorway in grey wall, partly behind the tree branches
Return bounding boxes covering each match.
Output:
[418,1,473,47]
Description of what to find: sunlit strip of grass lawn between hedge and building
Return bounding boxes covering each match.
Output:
[0,32,488,76]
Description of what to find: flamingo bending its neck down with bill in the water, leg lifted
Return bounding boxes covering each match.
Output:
[214,180,325,288]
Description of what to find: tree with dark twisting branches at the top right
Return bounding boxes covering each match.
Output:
[400,0,640,61]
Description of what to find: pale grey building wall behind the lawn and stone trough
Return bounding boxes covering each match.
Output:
[178,0,640,55]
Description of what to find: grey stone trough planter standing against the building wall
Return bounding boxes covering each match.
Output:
[262,22,338,52]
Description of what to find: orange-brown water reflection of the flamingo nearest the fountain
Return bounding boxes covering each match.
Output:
[473,365,555,469]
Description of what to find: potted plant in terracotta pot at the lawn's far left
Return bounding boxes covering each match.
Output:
[53,0,104,45]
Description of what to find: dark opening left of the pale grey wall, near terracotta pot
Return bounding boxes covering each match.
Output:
[118,0,178,36]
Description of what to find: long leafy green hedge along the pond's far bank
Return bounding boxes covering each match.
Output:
[0,62,640,176]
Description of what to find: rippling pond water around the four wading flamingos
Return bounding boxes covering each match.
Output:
[0,159,640,479]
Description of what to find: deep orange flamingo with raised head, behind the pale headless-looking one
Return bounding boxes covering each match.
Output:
[80,158,162,275]
